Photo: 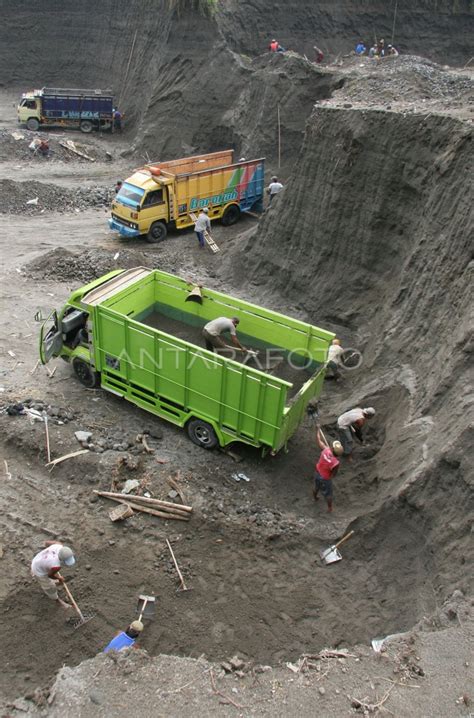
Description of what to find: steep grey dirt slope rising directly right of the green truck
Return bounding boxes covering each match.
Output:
[226,62,474,636]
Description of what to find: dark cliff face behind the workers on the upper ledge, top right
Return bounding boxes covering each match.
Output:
[219,0,474,65]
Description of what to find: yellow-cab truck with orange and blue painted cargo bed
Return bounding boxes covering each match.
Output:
[109,150,265,242]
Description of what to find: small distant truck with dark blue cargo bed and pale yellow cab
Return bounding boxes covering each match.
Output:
[17,87,115,133]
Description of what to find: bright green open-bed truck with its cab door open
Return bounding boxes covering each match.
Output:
[40,267,334,453]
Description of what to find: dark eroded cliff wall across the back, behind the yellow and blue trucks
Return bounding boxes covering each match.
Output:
[0,0,473,164]
